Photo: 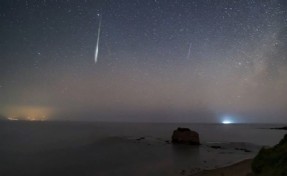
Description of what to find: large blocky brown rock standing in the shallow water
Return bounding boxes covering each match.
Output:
[171,128,200,145]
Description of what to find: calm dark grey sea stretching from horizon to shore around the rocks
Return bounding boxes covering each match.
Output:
[0,121,286,176]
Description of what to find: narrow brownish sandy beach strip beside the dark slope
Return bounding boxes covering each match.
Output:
[192,159,253,176]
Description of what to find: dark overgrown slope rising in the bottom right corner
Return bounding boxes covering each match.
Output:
[252,134,287,176]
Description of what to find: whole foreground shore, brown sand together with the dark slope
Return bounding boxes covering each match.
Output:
[195,134,287,176]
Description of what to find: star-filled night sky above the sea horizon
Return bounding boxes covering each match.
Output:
[0,0,287,123]
